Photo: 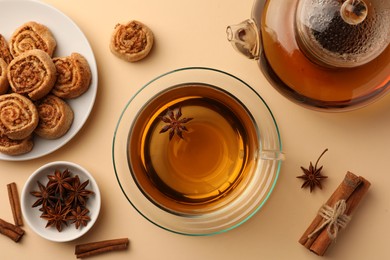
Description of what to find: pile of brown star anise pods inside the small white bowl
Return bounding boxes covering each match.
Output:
[30,169,94,232]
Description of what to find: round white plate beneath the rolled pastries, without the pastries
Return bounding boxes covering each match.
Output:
[0,0,98,161]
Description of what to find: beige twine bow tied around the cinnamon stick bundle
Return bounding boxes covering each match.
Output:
[308,200,351,240]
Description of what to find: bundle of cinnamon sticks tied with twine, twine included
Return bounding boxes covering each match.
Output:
[299,172,371,256]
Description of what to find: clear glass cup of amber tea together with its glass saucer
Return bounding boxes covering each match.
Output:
[113,68,284,235]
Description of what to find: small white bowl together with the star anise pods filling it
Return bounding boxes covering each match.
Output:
[21,161,101,242]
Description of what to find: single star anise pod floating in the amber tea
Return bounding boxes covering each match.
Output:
[160,107,193,140]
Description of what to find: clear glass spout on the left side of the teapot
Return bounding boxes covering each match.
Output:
[226,19,260,59]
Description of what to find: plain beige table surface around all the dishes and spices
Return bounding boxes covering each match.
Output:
[0,0,390,260]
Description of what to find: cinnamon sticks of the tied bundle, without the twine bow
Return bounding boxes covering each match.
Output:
[299,172,370,256]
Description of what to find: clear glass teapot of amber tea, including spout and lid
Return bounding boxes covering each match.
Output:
[227,0,390,111]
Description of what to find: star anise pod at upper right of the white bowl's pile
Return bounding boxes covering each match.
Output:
[64,175,93,206]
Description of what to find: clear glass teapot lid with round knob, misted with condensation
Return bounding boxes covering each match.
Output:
[295,0,390,68]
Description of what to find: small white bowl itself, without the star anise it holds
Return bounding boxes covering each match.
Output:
[21,161,101,242]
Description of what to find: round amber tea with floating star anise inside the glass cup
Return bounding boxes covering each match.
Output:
[128,83,259,215]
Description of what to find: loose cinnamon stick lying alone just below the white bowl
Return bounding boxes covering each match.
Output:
[75,238,129,258]
